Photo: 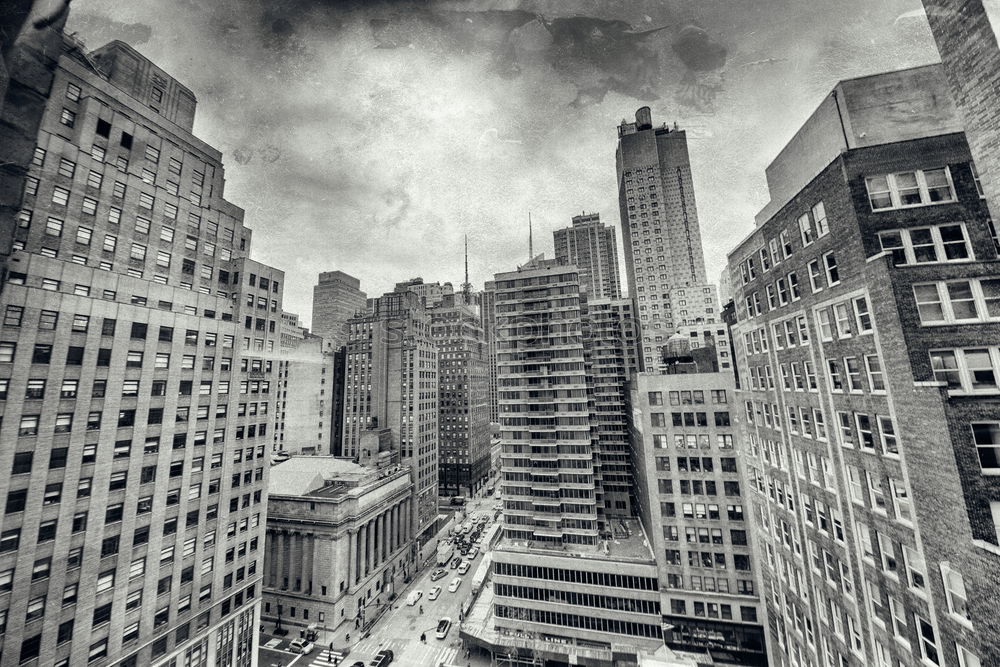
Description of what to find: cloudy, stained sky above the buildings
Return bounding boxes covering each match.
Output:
[67,0,938,323]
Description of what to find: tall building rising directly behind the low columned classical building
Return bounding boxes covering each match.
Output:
[341,291,438,542]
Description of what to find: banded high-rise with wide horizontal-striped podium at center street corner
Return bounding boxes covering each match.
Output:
[462,256,666,665]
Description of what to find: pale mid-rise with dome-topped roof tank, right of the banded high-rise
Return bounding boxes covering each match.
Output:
[629,354,768,665]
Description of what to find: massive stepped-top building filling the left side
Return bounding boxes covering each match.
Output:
[0,38,283,666]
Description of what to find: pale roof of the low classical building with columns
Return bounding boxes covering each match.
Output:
[267,456,379,497]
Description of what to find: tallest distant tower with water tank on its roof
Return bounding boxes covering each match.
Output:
[615,107,719,370]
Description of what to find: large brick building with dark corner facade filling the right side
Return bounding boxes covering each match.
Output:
[729,65,1000,666]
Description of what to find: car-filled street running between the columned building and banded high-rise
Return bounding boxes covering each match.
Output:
[261,497,496,667]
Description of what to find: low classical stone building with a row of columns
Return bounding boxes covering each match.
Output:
[262,450,414,639]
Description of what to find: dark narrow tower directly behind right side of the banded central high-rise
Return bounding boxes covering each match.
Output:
[583,299,638,517]
